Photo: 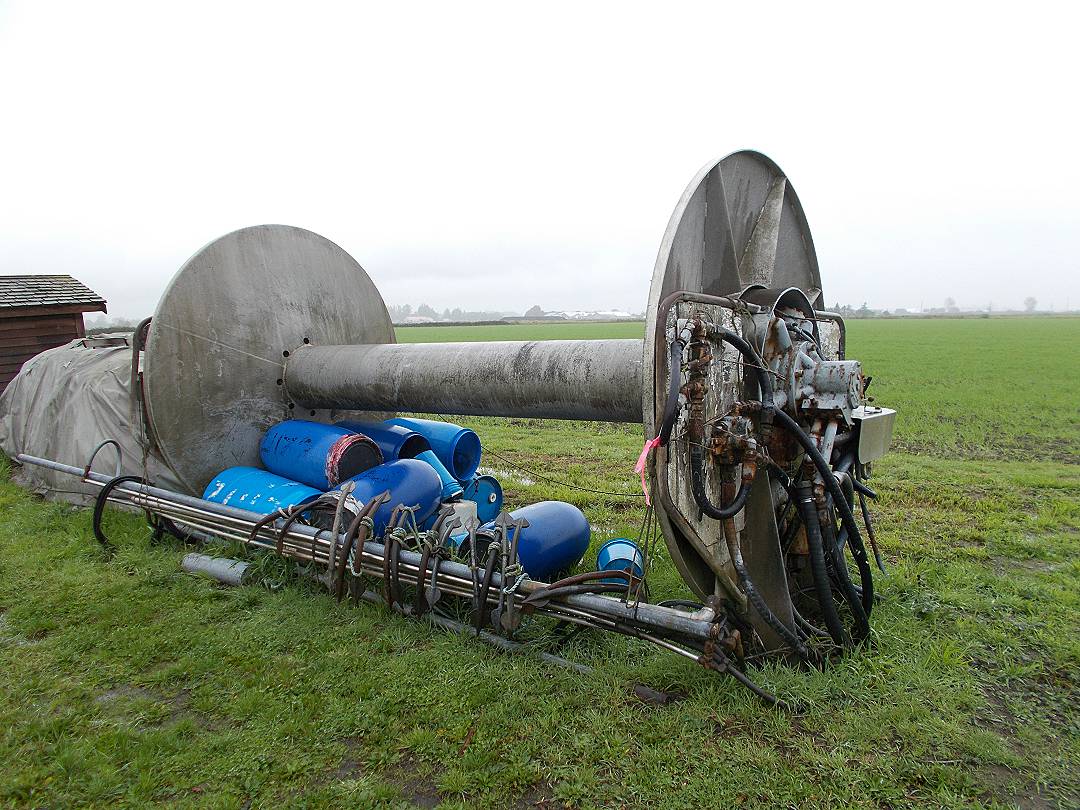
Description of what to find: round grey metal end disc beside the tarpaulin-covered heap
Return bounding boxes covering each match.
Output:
[143,225,394,494]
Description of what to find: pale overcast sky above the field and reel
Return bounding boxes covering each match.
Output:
[0,0,1080,318]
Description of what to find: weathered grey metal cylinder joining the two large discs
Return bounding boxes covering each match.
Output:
[285,340,642,422]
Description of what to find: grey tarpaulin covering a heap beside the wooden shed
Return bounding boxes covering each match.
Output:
[0,333,185,502]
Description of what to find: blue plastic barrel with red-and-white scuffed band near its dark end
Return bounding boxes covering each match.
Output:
[259,419,382,491]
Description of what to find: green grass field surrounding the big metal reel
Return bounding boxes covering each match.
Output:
[0,319,1080,808]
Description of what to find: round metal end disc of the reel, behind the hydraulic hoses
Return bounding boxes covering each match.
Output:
[642,151,821,597]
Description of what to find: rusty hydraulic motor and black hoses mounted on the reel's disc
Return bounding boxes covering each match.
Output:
[657,288,874,662]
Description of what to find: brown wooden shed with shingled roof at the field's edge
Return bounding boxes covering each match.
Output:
[0,275,106,391]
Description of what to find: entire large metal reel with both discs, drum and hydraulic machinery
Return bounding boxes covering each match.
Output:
[128,151,891,673]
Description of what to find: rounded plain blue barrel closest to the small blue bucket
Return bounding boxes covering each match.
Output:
[483,501,590,582]
